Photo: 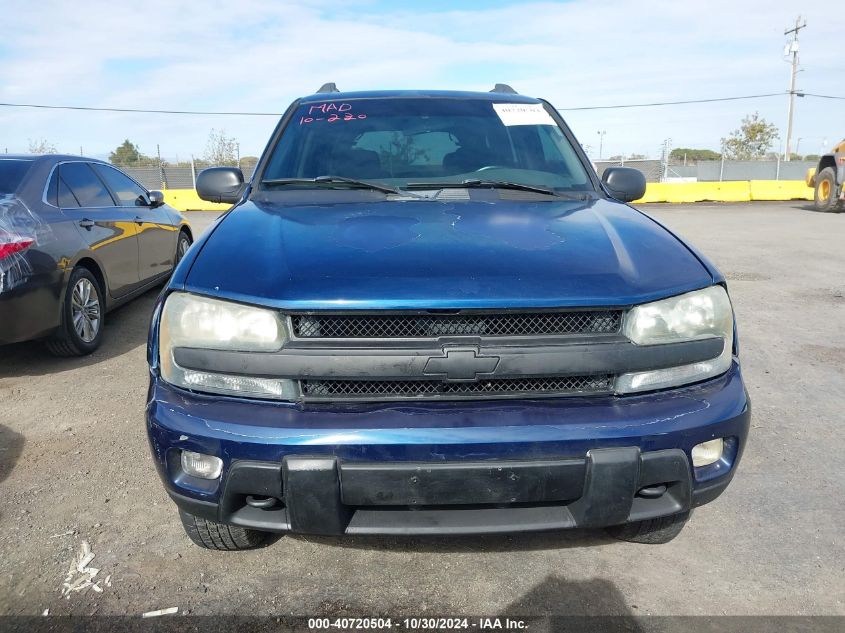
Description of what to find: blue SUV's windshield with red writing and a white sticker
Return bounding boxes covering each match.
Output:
[262,97,593,191]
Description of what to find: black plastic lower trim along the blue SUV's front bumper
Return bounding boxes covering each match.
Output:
[163,447,732,534]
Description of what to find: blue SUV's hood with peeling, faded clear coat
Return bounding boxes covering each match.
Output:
[185,199,713,310]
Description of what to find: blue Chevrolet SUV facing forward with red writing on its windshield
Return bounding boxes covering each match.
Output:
[146,84,749,550]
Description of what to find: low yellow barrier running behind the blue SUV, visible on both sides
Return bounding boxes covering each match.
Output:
[164,180,813,212]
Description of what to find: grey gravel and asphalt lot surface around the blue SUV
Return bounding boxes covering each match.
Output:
[0,203,845,615]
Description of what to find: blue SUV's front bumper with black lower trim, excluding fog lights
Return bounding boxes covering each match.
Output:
[147,365,749,534]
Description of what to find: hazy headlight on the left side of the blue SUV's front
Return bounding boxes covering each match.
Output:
[159,292,296,400]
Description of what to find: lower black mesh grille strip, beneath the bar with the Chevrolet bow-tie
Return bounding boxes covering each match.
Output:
[301,374,613,400]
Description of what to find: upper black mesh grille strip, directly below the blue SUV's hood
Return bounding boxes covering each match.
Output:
[291,310,622,338]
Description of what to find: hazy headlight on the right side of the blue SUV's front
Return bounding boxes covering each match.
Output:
[616,286,733,393]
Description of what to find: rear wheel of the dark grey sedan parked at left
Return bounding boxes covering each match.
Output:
[46,267,106,356]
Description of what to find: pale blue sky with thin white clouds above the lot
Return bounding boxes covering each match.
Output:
[0,0,845,161]
